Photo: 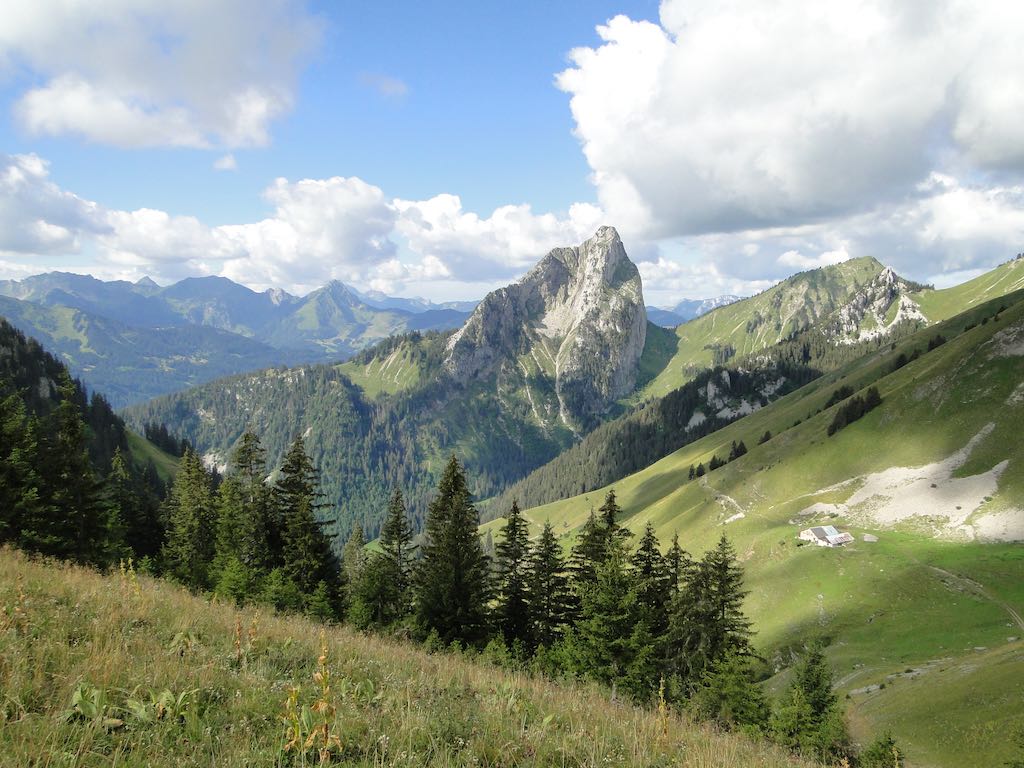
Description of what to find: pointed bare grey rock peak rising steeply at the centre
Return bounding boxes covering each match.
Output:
[444,226,647,429]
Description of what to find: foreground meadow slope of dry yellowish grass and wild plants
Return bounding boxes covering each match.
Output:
[0,550,808,768]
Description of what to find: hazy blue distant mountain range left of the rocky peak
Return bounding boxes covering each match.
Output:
[0,272,474,407]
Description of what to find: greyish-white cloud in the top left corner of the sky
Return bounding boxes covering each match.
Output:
[0,0,319,147]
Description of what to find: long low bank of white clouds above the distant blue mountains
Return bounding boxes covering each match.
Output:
[0,156,601,298]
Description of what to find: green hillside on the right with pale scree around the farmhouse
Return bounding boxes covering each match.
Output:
[501,292,1024,767]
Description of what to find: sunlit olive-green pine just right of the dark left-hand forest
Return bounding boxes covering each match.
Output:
[163,451,216,589]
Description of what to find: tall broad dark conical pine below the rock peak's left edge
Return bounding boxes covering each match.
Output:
[416,456,489,644]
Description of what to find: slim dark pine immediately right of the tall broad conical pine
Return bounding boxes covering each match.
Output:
[495,501,532,647]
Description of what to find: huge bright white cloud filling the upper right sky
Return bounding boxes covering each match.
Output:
[556,0,1024,241]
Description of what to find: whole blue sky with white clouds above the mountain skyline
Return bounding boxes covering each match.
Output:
[0,0,1024,306]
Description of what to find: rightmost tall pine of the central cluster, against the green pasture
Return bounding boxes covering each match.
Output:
[668,536,751,686]
